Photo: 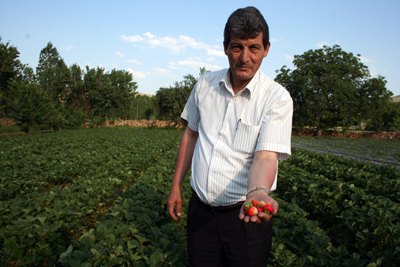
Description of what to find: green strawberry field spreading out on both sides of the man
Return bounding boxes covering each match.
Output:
[0,127,400,267]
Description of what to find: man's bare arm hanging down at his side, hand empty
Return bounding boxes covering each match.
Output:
[167,127,199,221]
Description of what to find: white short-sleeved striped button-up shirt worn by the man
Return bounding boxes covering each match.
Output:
[181,69,293,206]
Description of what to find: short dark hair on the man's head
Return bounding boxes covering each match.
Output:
[224,6,269,49]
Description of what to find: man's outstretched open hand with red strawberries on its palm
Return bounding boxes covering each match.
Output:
[239,190,279,224]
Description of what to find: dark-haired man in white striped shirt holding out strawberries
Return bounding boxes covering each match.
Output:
[168,7,293,267]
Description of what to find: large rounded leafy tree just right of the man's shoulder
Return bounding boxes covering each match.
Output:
[275,45,369,136]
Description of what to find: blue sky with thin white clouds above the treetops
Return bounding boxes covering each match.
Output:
[0,0,400,96]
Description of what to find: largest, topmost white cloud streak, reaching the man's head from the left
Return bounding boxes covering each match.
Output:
[121,32,225,56]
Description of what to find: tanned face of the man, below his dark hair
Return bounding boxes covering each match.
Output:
[224,32,270,85]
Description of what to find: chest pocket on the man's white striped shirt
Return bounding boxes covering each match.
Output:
[233,121,261,153]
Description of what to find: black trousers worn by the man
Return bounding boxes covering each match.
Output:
[187,193,272,267]
